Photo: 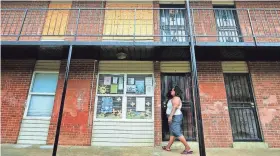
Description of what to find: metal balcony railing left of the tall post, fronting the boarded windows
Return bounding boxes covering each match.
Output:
[1,8,188,43]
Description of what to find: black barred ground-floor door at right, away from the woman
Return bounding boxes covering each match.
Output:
[224,73,261,141]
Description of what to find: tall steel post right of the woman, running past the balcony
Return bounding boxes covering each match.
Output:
[186,0,206,156]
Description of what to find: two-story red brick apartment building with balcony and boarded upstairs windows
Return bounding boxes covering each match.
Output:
[1,0,280,148]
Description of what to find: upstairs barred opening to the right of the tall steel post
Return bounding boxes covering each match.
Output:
[214,7,242,42]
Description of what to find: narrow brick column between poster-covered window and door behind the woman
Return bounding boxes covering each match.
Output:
[154,62,162,146]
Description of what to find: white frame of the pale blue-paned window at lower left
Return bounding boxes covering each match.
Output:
[23,71,59,119]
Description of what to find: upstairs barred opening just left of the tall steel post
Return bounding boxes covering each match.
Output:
[160,5,187,42]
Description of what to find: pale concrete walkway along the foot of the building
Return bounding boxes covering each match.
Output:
[1,145,280,156]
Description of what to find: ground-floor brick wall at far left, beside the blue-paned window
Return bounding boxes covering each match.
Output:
[1,60,35,143]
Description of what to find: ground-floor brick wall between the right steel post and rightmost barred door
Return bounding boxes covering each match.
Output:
[197,62,233,147]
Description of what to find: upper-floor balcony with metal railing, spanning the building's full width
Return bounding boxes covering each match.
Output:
[1,8,280,46]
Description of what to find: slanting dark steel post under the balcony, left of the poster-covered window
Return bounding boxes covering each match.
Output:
[52,45,72,156]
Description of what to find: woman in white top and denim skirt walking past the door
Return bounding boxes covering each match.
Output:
[162,86,193,154]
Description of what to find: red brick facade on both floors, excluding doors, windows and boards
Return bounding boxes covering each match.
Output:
[1,2,280,148]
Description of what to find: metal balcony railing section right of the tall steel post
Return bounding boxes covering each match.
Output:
[191,8,280,43]
